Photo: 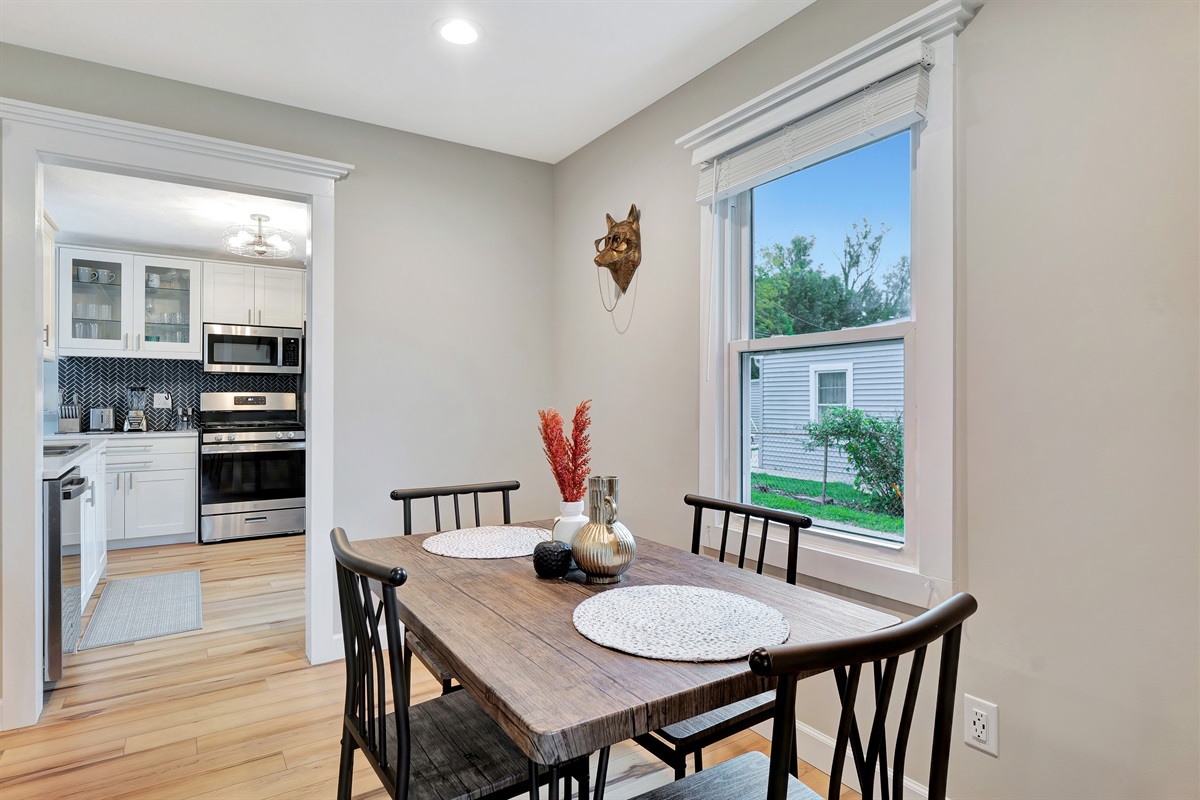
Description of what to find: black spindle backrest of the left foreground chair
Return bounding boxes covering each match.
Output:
[329,528,410,798]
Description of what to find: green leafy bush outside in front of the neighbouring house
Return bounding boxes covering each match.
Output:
[804,407,904,517]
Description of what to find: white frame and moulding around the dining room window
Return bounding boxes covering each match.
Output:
[679,0,982,608]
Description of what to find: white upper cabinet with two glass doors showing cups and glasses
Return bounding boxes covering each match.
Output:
[59,247,203,359]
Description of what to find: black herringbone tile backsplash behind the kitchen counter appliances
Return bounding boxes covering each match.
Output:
[59,357,300,431]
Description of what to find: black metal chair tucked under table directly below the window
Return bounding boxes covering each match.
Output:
[634,494,812,780]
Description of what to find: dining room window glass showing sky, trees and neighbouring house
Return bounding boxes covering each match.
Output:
[731,131,912,543]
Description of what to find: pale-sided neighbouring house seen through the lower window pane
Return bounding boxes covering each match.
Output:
[749,339,904,483]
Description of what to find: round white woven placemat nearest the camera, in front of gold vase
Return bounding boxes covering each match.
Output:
[574,585,791,661]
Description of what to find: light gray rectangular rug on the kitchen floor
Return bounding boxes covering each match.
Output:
[79,570,203,650]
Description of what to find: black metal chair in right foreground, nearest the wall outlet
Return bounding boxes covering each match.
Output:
[636,593,978,800]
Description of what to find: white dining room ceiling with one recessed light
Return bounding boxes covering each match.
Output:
[0,0,812,163]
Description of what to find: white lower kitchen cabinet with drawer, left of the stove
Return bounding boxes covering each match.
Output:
[106,434,197,542]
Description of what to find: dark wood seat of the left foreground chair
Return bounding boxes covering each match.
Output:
[355,692,540,800]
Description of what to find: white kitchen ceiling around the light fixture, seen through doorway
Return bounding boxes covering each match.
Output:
[43,164,308,267]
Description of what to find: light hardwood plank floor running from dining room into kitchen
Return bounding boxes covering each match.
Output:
[0,536,858,800]
